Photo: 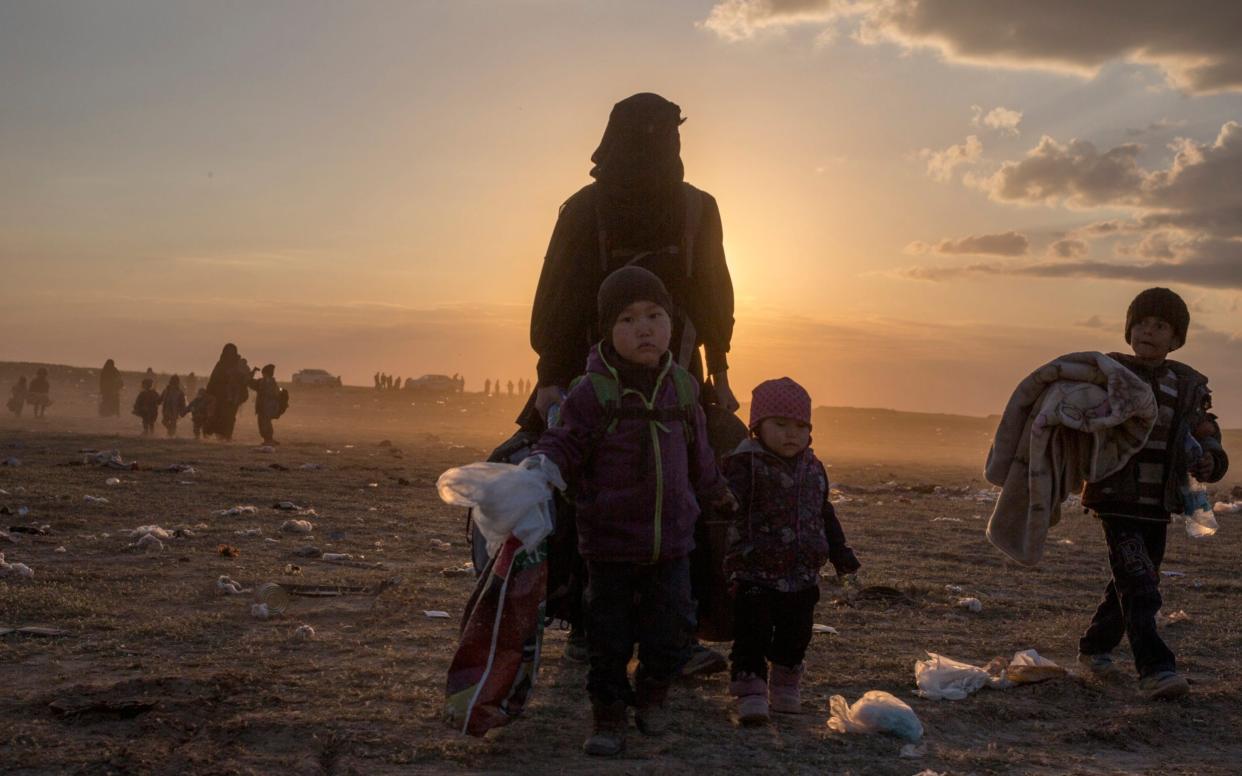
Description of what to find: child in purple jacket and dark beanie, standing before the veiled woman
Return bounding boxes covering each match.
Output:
[533,266,733,756]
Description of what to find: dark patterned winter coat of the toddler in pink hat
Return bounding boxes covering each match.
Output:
[724,440,858,592]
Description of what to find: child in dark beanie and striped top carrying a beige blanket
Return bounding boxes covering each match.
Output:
[1078,288,1230,700]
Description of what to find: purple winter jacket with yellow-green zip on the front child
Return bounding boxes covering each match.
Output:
[532,345,728,564]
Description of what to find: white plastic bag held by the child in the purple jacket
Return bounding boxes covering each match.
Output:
[436,456,565,556]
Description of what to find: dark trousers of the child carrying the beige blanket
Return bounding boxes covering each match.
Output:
[1078,518,1176,677]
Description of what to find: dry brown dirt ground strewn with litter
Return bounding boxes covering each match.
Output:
[0,377,1242,776]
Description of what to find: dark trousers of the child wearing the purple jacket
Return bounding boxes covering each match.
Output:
[586,557,694,703]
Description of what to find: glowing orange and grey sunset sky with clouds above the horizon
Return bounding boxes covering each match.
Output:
[0,0,1242,426]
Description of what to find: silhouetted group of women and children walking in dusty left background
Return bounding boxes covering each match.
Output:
[9,343,289,444]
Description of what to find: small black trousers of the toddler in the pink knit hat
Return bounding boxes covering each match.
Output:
[729,582,820,679]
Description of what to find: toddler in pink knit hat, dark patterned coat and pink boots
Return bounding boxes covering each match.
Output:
[724,377,859,725]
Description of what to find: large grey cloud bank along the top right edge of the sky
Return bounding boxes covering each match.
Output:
[703,0,1242,93]
